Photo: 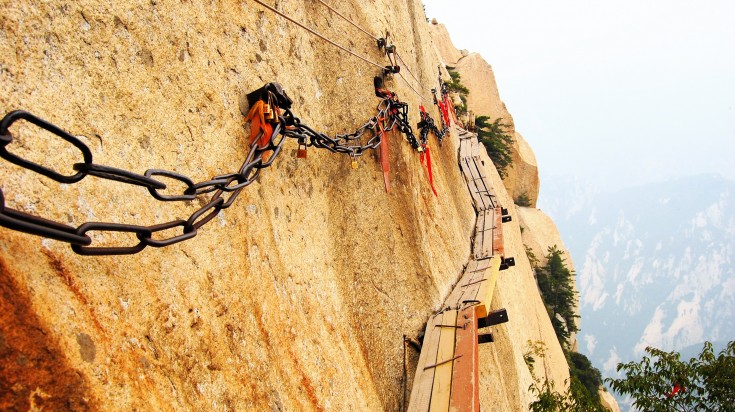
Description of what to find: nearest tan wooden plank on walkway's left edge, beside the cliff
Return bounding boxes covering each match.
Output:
[408,316,442,412]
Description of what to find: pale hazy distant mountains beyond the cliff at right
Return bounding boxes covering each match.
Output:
[540,175,735,408]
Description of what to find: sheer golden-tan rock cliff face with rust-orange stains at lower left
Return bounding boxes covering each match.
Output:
[0,0,568,411]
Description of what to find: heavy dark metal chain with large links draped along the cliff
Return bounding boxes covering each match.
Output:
[0,83,418,255]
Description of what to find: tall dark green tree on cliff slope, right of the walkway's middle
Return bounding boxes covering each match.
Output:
[537,245,579,347]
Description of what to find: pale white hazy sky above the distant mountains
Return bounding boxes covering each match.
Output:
[424,0,735,196]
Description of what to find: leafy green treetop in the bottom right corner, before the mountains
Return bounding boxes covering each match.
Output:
[605,341,735,412]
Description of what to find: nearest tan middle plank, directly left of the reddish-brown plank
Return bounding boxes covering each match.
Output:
[429,310,458,412]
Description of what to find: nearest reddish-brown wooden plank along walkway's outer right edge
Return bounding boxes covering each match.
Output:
[449,307,480,412]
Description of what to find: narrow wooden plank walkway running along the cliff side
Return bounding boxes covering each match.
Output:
[408,128,504,412]
